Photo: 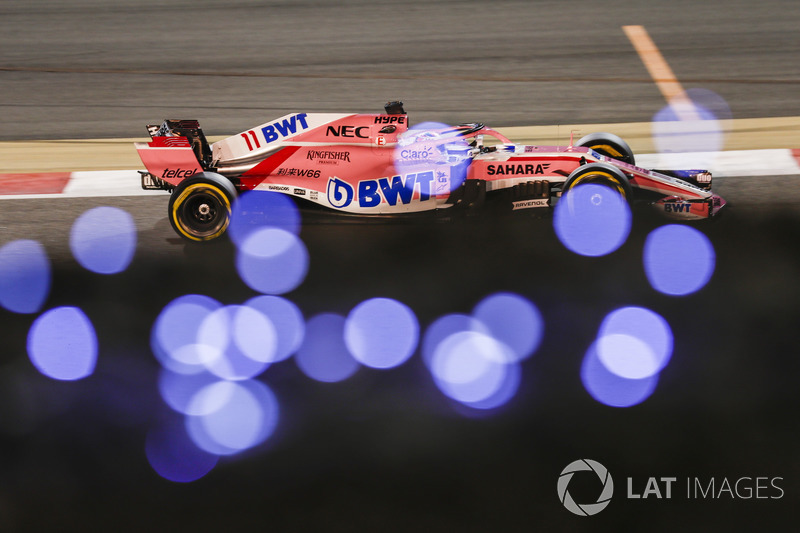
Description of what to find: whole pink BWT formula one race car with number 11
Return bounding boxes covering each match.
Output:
[136,102,725,241]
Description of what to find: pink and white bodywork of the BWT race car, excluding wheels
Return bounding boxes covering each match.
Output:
[136,113,724,218]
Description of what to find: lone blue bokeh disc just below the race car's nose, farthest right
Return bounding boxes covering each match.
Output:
[644,224,716,296]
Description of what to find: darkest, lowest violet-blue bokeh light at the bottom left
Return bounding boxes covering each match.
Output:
[145,416,219,483]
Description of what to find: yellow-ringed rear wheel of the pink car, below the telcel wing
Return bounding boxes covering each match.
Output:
[168,172,236,242]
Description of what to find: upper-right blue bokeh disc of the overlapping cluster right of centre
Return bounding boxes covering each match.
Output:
[472,292,544,361]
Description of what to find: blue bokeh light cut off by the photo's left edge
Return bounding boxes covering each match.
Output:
[0,240,52,313]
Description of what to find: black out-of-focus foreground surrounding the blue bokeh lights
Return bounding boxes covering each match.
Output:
[0,198,800,531]
